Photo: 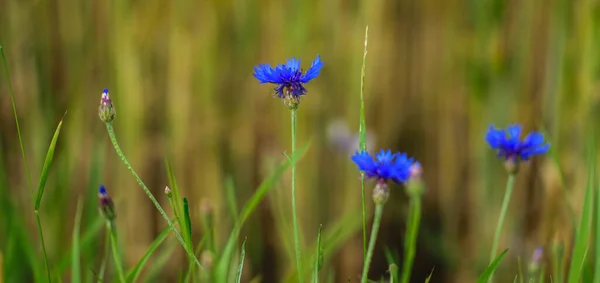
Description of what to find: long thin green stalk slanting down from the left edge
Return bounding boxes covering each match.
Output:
[0,43,52,282]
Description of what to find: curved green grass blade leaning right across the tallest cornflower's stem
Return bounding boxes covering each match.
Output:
[214,142,310,282]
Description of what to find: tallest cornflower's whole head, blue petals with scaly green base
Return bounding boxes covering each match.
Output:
[253,56,323,109]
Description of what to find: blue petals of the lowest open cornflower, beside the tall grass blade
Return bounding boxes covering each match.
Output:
[352,149,420,184]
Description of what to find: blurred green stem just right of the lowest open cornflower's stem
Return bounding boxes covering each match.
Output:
[400,195,421,283]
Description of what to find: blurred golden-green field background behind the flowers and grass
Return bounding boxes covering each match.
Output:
[0,0,600,282]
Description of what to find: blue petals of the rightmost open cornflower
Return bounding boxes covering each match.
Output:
[485,124,550,162]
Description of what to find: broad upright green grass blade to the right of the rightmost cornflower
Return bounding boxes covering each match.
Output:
[567,139,596,283]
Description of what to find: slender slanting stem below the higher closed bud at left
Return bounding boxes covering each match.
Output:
[106,123,204,270]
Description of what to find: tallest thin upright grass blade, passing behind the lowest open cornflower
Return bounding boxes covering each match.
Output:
[358,25,369,260]
